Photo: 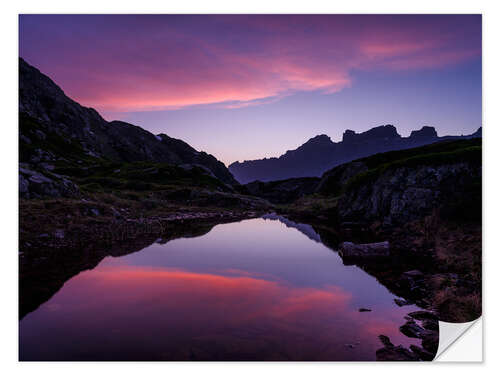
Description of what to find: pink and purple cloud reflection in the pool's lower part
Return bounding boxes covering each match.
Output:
[24,263,422,360]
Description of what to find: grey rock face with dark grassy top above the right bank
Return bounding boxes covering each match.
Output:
[316,139,481,225]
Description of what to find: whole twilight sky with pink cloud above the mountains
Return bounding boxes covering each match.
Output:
[19,15,482,165]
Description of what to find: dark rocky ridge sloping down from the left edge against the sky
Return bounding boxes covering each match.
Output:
[19,59,237,185]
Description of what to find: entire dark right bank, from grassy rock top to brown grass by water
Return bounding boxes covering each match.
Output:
[302,139,482,324]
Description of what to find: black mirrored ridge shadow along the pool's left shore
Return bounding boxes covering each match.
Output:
[19,203,264,320]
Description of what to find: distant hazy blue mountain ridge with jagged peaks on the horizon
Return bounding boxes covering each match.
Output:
[229,125,481,184]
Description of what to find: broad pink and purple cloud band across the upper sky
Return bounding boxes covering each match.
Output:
[21,15,481,112]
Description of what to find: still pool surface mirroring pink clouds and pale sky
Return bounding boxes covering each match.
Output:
[19,218,418,360]
